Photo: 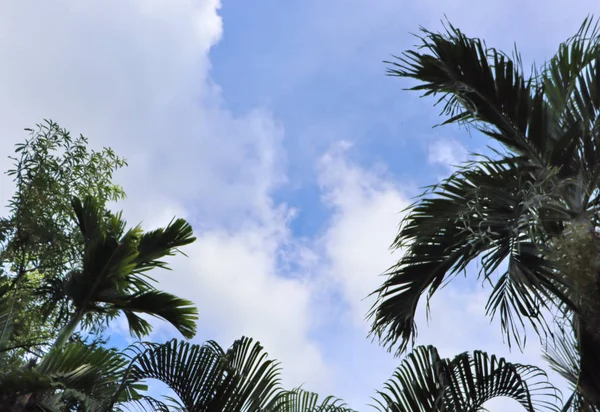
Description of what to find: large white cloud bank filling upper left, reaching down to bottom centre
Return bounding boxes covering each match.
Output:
[0,0,330,396]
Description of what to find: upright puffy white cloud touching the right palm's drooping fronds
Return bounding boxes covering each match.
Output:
[320,142,409,325]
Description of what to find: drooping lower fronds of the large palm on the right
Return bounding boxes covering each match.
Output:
[369,157,573,353]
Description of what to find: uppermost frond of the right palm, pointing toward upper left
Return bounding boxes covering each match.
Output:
[386,23,548,161]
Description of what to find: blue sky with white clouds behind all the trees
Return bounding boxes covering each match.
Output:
[0,0,600,411]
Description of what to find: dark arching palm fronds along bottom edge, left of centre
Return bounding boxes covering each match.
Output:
[112,337,353,412]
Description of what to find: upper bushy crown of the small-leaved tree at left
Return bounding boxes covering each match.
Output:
[0,121,126,280]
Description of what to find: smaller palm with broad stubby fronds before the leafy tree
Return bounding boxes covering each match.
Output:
[39,197,198,347]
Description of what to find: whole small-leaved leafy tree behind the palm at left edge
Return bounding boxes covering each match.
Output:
[0,121,126,362]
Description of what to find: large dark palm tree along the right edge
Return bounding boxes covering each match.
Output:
[370,18,600,408]
